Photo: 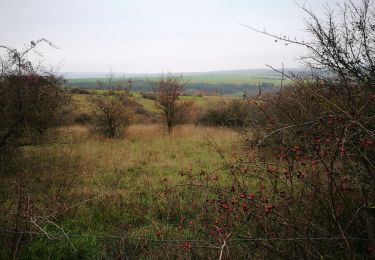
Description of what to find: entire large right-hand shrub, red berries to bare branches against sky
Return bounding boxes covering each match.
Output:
[176,0,375,259]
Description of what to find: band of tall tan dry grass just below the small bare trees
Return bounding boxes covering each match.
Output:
[59,125,239,183]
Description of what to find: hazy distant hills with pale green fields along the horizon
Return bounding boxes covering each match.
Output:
[63,69,303,96]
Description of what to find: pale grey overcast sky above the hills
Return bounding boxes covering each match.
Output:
[0,0,346,73]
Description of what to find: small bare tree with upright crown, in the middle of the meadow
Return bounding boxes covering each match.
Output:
[149,74,193,134]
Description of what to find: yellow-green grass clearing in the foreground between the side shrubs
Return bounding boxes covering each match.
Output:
[0,125,240,258]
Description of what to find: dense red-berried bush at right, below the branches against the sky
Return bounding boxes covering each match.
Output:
[176,80,375,258]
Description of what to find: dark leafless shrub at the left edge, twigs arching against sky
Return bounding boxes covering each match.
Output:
[0,39,70,168]
